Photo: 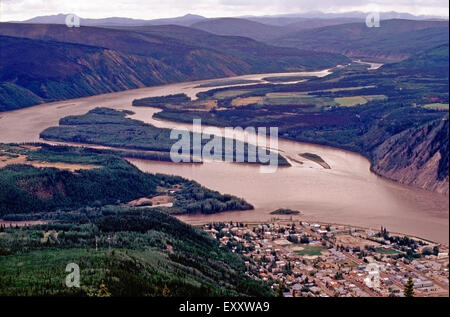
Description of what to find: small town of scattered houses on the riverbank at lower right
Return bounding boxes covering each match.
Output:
[203,220,449,297]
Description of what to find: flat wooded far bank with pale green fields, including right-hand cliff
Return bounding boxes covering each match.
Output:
[147,45,449,194]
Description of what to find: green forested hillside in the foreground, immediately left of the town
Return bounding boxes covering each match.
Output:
[0,207,273,296]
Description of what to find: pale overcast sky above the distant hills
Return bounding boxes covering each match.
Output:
[0,0,449,21]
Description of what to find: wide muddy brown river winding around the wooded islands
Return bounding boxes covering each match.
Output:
[0,71,449,245]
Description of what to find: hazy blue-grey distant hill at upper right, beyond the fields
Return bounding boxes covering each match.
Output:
[271,19,449,61]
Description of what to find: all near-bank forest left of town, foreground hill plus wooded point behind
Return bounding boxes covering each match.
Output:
[0,144,273,296]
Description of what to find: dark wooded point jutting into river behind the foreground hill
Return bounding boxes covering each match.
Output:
[0,144,253,219]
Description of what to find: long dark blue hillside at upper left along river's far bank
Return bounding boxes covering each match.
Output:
[0,23,349,111]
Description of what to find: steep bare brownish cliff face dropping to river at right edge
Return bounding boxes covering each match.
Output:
[372,117,449,194]
